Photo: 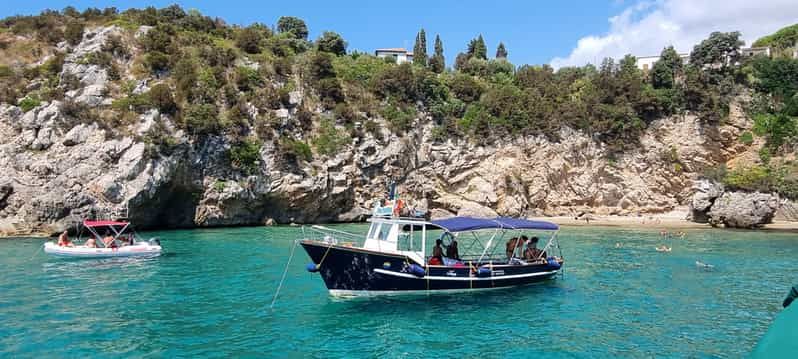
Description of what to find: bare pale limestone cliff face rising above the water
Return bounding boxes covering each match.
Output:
[0,23,780,234]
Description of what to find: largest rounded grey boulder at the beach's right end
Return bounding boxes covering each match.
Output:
[709,192,779,228]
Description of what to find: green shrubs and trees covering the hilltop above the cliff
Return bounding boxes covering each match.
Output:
[0,5,798,172]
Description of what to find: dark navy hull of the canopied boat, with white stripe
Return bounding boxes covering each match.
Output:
[300,241,560,295]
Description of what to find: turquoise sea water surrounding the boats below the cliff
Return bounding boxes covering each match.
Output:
[0,225,798,358]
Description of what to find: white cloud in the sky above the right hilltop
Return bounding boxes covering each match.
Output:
[551,0,798,68]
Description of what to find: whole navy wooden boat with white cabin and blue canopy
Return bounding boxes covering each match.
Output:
[299,211,563,296]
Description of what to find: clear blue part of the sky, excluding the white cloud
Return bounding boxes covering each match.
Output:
[0,0,619,63]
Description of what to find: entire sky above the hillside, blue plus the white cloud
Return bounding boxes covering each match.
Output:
[0,0,798,67]
